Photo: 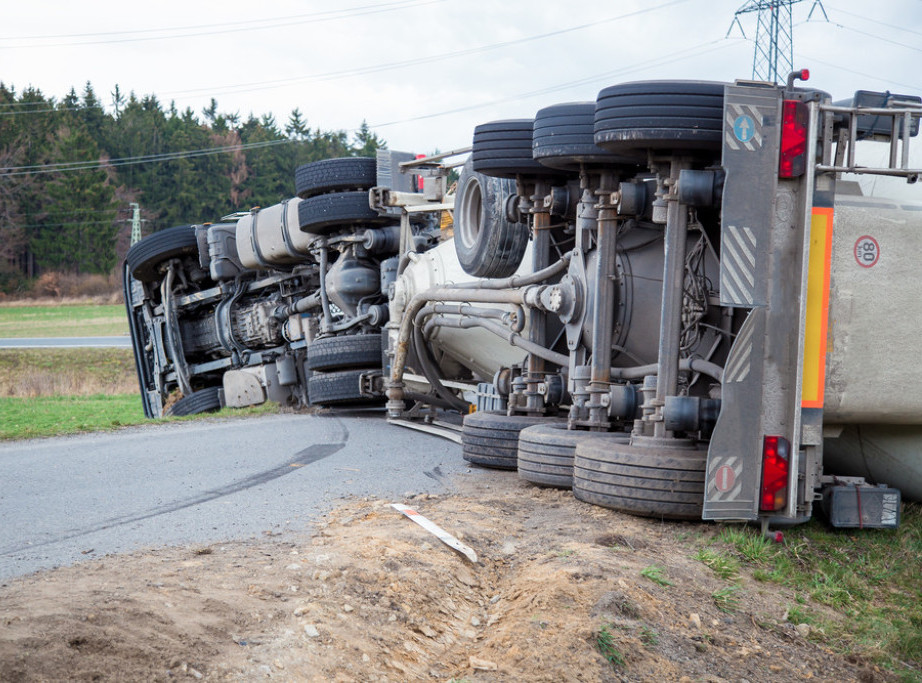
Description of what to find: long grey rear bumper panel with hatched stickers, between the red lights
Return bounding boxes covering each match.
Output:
[702,84,816,520]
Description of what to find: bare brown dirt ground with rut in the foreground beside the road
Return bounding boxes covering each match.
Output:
[0,474,887,681]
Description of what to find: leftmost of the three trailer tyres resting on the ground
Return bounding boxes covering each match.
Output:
[461,412,566,470]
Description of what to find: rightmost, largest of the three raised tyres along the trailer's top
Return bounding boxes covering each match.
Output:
[595,81,725,158]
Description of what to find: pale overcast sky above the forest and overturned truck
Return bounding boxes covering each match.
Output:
[0,0,922,152]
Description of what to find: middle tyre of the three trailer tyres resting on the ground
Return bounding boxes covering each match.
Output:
[518,422,630,489]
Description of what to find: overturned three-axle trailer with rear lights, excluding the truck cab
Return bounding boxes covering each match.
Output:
[388,74,922,527]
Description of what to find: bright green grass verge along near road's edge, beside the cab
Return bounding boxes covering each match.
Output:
[0,394,278,441]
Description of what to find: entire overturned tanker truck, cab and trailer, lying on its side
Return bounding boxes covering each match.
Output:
[125,72,922,528]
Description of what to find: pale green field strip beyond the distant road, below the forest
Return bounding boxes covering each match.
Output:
[0,304,128,338]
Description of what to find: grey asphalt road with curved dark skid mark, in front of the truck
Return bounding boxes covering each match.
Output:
[0,413,474,579]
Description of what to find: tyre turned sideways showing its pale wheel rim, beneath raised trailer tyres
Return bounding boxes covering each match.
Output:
[455,159,528,277]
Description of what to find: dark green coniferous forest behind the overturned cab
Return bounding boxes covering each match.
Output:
[0,83,384,292]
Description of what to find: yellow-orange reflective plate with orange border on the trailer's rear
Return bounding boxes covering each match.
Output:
[800,207,833,408]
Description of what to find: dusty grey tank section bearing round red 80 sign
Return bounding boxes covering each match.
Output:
[823,194,922,500]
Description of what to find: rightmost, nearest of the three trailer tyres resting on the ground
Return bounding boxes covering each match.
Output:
[573,439,707,520]
